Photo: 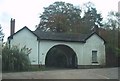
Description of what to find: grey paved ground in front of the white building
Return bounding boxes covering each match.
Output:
[2,68,118,79]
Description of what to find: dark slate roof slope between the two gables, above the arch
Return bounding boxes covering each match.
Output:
[34,30,88,42]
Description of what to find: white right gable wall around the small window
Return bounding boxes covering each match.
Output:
[82,34,105,65]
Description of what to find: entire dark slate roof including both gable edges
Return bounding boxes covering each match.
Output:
[8,26,105,43]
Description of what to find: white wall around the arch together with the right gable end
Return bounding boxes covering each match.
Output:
[39,34,105,65]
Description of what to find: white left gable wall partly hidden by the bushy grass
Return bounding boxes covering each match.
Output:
[11,28,38,64]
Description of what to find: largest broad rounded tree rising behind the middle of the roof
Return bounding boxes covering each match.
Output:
[38,2,81,32]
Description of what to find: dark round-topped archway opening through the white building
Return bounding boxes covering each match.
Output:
[45,45,77,68]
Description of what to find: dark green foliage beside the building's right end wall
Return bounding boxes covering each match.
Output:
[100,29,120,66]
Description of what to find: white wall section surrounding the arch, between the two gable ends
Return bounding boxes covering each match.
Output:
[39,40,83,65]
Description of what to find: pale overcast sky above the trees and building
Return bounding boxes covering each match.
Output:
[0,0,120,41]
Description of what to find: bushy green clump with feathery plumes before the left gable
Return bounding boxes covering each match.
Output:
[2,44,31,71]
